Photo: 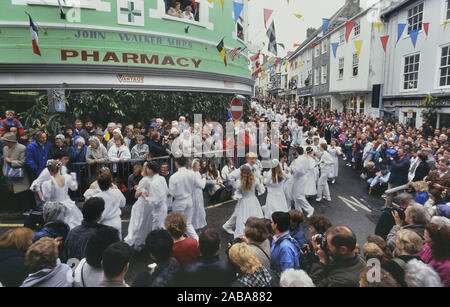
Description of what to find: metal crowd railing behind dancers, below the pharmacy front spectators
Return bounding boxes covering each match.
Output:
[70,149,239,199]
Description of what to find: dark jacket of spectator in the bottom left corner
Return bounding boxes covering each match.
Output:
[0,247,28,287]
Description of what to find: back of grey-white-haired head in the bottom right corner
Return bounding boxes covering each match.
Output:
[405,259,442,287]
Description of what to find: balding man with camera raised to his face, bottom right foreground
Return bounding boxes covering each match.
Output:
[309,226,366,287]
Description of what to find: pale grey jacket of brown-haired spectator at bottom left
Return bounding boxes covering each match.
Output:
[21,259,73,287]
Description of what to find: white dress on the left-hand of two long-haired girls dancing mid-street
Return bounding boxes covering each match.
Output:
[234,180,265,238]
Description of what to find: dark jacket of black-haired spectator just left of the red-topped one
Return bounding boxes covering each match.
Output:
[132,257,181,287]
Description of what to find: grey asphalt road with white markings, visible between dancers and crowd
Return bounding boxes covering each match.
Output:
[0,161,384,283]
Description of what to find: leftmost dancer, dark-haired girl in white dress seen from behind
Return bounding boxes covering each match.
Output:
[42,160,83,229]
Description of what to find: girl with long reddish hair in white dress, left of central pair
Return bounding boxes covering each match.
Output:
[233,165,265,238]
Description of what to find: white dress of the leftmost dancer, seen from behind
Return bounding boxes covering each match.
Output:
[42,175,83,229]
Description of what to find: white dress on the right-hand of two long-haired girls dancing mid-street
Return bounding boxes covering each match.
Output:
[264,171,289,220]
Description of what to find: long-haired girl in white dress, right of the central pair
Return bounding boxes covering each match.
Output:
[264,159,289,220]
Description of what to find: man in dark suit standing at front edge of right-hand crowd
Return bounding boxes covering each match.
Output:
[383,148,411,209]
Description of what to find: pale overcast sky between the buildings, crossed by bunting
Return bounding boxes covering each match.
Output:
[248,0,375,57]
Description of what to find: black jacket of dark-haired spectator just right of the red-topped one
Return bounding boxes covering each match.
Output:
[177,256,236,287]
